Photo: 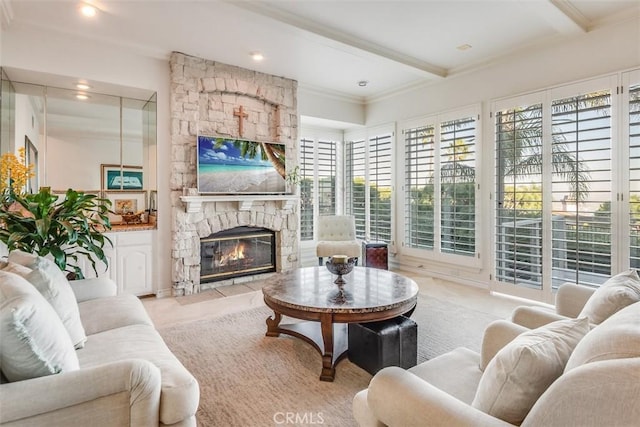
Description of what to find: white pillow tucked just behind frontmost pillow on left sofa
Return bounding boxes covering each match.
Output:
[9,251,87,349]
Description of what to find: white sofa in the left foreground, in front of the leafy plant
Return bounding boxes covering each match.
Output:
[0,252,200,427]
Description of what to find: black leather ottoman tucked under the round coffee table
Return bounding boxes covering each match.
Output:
[348,316,418,375]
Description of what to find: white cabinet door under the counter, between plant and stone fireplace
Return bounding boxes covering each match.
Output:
[116,245,153,295]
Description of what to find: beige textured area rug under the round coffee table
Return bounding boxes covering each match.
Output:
[160,296,495,427]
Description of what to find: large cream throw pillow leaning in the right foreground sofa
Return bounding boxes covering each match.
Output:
[471,318,589,425]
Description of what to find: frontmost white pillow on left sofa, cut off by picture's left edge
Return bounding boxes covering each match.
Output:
[0,271,79,381]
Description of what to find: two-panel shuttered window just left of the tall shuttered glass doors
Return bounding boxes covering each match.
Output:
[402,108,479,262]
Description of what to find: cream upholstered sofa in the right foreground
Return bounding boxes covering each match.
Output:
[353,276,640,427]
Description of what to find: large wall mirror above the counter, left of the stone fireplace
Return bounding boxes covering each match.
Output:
[0,68,157,224]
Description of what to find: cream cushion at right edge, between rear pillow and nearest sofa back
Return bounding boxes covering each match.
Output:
[564,303,640,372]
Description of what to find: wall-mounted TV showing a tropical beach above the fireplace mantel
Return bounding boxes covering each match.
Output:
[198,136,286,194]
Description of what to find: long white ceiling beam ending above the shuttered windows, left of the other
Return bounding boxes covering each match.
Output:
[228,0,447,79]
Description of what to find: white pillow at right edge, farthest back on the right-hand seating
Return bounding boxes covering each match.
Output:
[578,270,640,325]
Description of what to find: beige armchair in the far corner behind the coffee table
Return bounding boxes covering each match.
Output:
[316,215,361,265]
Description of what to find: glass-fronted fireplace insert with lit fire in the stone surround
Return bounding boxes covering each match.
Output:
[200,227,276,283]
